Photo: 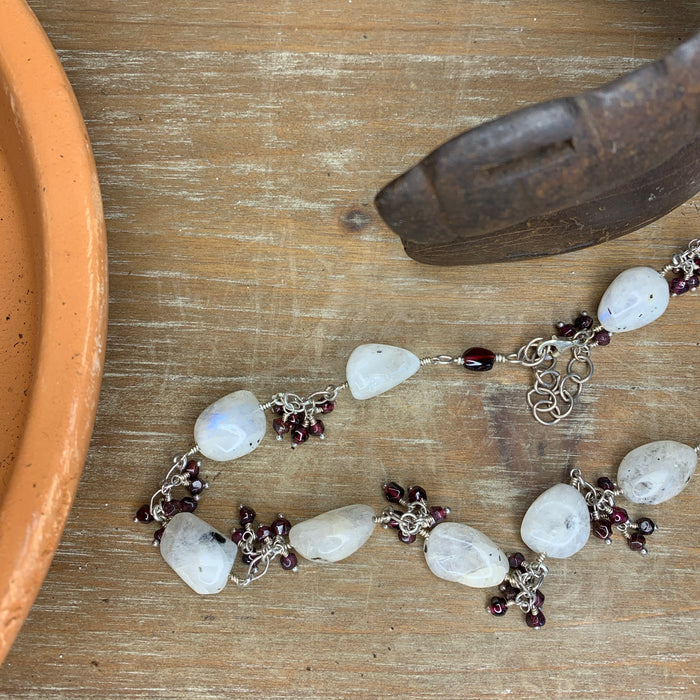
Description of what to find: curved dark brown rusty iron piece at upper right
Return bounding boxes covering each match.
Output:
[375,33,700,265]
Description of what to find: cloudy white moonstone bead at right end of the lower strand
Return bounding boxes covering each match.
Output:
[617,440,698,503]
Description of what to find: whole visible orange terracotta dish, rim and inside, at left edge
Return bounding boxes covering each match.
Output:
[0,0,107,662]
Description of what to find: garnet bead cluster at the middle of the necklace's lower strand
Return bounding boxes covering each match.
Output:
[376,481,450,544]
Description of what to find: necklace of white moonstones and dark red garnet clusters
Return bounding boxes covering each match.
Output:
[135,239,700,629]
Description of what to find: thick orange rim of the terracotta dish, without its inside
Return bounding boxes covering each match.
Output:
[0,0,107,662]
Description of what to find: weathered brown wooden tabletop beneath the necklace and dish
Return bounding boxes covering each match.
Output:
[0,0,700,699]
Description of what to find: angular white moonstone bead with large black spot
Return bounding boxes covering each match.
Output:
[160,513,237,595]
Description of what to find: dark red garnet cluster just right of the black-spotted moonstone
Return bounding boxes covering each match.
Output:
[231,505,298,571]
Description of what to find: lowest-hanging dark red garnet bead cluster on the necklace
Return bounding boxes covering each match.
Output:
[486,552,547,629]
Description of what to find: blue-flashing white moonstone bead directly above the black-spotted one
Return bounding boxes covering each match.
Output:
[194,391,266,462]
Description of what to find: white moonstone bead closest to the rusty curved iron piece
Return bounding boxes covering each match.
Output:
[598,267,671,333]
